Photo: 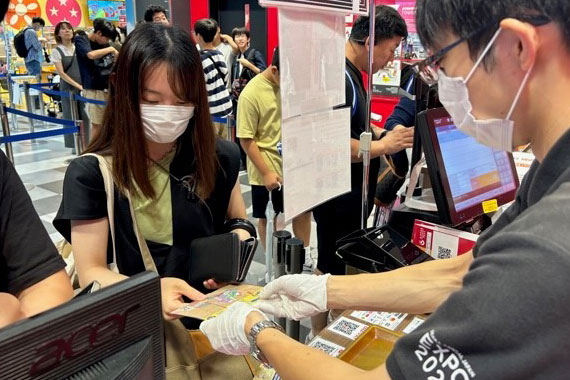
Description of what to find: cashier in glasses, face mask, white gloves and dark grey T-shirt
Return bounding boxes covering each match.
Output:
[201,0,570,380]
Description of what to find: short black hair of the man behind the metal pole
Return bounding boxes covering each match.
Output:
[350,5,408,45]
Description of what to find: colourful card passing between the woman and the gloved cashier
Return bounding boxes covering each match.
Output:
[172,285,263,321]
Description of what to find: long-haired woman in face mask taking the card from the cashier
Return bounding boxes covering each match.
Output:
[54,24,249,319]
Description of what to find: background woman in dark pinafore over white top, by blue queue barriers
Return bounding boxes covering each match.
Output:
[51,21,86,153]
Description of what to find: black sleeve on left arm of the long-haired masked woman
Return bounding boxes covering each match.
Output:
[53,156,107,241]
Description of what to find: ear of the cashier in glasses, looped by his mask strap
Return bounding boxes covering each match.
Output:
[501,18,540,71]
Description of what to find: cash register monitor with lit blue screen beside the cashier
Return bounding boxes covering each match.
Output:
[417,108,519,226]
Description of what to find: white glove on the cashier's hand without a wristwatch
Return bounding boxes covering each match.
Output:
[255,274,330,321]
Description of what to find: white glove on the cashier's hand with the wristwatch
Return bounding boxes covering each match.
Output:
[200,302,267,355]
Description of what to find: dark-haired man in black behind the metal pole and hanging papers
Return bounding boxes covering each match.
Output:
[313,6,413,280]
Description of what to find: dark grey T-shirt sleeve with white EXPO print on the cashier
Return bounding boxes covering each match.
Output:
[387,196,570,380]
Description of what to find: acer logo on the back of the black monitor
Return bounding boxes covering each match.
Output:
[30,304,141,376]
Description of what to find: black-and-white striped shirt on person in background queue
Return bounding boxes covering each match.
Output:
[200,50,232,117]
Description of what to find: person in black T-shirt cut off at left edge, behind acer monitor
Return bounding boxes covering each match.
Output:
[0,151,73,327]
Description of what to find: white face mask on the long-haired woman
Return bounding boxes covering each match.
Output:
[141,104,195,144]
